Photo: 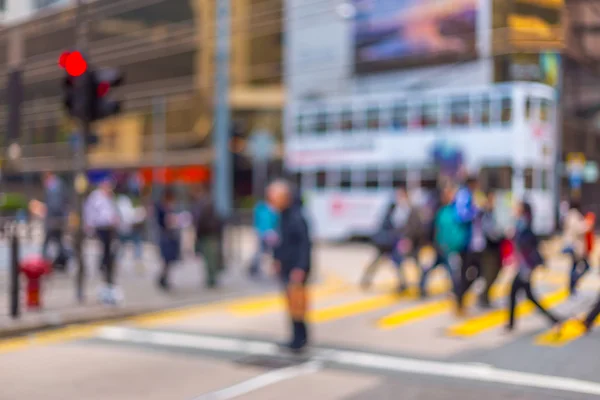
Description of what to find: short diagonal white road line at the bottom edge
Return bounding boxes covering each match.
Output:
[194,361,323,400]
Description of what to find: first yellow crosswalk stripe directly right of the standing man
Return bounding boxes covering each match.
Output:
[308,281,449,323]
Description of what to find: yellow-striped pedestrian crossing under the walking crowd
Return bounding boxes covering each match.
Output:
[143,270,597,347]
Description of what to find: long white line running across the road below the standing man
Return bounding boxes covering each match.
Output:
[97,327,600,396]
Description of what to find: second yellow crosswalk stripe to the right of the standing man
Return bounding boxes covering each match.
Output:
[377,285,508,330]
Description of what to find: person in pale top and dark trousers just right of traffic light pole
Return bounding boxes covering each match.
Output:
[83,179,122,304]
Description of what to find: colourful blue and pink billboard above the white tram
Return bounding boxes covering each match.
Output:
[352,0,479,73]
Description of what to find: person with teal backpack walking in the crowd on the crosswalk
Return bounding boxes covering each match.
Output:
[419,185,467,297]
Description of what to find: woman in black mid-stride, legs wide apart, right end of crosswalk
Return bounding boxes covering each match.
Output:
[506,202,560,331]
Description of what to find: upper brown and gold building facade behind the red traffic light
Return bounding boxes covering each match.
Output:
[0,0,284,185]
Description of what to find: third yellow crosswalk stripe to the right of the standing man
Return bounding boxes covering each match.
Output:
[448,290,569,337]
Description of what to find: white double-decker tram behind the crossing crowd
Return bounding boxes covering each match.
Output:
[284,82,556,240]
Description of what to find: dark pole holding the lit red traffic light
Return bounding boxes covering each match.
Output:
[74,0,90,302]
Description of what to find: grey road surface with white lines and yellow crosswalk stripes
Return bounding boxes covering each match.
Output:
[0,246,600,400]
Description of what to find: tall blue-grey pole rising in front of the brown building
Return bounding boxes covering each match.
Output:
[212,0,233,218]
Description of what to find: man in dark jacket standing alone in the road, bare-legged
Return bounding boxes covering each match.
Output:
[267,181,312,351]
